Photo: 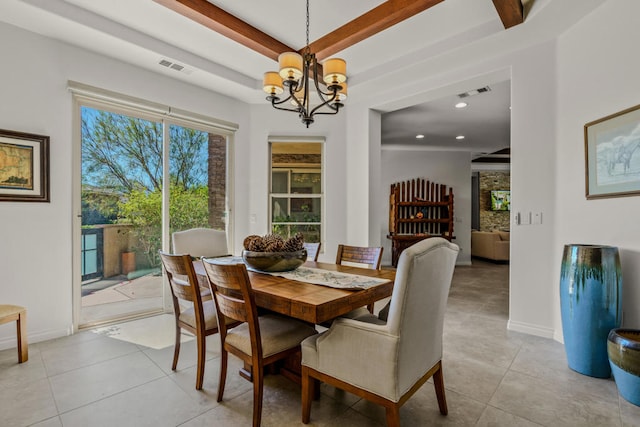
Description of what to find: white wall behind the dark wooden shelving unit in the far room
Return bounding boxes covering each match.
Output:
[375,149,471,265]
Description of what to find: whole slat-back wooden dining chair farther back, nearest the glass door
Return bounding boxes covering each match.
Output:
[160,251,218,390]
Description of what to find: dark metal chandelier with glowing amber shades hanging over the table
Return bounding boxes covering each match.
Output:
[262,0,347,127]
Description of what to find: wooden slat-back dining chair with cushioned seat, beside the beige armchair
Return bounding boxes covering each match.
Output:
[203,259,317,427]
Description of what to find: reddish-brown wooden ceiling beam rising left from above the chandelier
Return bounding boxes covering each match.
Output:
[153,0,295,61]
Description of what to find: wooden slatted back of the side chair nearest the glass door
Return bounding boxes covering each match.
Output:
[160,251,202,306]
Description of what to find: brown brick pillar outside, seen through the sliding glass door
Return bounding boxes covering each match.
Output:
[208,133,227,230]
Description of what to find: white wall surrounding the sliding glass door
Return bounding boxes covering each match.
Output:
[0,23,249,348]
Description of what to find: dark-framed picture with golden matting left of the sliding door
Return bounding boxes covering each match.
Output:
[0,129,49,202]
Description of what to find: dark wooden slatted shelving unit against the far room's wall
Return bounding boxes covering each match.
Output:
[387,178,455,267]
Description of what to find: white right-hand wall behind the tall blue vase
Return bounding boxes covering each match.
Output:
[553,0,640,332]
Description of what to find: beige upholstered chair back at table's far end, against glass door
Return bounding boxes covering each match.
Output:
[171,228,229,258]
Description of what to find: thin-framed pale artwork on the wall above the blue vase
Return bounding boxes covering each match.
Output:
[584,105,640,199]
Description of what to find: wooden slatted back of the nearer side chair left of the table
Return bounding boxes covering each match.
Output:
[202,259,258,325]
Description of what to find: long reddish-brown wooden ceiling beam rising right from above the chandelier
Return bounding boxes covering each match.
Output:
[310,0,442,60]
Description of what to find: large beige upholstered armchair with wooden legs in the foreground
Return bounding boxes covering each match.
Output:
[302,237,459,426]
